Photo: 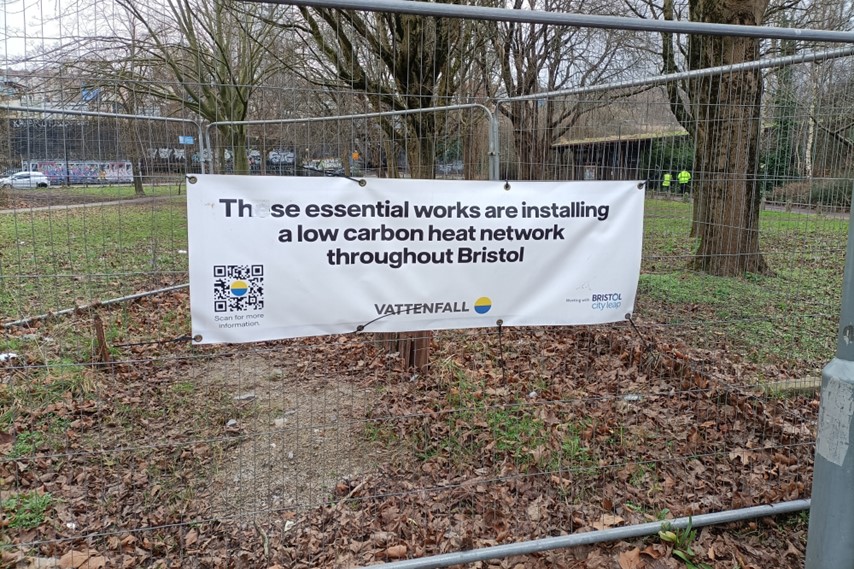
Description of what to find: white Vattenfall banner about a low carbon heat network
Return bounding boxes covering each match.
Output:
[187,175,644,344]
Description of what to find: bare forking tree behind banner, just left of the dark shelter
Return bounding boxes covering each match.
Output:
[480,0,648,180]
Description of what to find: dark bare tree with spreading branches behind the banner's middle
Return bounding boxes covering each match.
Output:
[282,8,474,178]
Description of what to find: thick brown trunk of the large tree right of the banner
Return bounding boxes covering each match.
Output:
[691,0,768,276]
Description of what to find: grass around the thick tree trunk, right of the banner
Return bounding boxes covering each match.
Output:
[638,200,848,368]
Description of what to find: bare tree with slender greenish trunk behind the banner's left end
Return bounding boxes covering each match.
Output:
[66,0,285,173]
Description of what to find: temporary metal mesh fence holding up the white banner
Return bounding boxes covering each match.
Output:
[0,2,854,567]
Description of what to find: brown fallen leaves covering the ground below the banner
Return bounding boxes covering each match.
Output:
[0,299,818,568]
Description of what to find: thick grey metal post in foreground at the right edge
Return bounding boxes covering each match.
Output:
[806,185,854,569]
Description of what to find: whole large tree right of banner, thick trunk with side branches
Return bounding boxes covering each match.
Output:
[626,0,852,275]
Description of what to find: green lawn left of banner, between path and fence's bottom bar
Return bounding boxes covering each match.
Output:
[0,200,187,320]
